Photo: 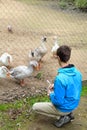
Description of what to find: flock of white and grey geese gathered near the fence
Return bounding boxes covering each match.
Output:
[0,36,59,86]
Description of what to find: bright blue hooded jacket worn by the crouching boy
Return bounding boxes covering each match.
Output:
[50,65,82,112]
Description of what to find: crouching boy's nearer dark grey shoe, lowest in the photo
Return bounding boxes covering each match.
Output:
[54,115,71,128]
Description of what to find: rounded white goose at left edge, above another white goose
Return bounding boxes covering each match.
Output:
[0,52,13,68]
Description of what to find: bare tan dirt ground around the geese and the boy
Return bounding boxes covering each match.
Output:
[0,0,87,130]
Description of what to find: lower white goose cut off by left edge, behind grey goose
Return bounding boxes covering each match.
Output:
[0,66,10,78]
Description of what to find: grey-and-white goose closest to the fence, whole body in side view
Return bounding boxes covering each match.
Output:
[10,60,38,86]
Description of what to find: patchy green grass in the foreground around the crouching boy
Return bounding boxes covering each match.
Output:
[0,86,87,130]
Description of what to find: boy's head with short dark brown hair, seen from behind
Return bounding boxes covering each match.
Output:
[56,45,71,63]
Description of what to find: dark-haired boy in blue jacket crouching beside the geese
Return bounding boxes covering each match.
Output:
[33,45,82,127]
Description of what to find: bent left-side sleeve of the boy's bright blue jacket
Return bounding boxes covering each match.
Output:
[50,77,65,106]
